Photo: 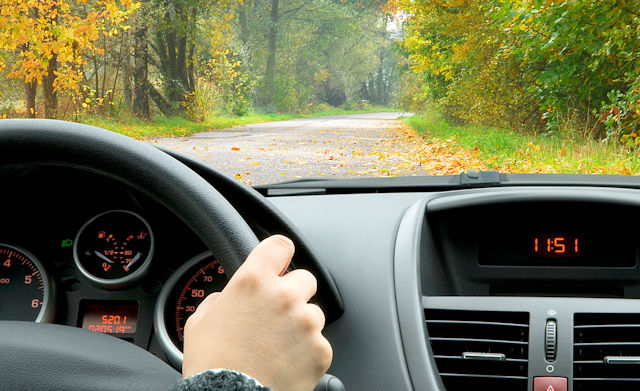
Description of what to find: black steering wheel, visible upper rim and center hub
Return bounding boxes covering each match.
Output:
[0,119,258,391]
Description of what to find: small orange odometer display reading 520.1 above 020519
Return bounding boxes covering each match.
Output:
[82,302,138,334]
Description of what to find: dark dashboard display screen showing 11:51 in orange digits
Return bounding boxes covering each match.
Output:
[468,201,640,268]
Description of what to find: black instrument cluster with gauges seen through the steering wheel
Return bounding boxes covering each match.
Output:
[0,166,212,359]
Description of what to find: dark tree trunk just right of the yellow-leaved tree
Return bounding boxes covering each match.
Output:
[133,21,151,119]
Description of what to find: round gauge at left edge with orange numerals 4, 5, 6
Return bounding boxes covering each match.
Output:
[0,244,52,322]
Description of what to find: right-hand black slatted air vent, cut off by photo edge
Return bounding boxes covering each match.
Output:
[573,314,640,391]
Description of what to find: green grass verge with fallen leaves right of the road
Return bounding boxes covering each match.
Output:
[403,111,640,175]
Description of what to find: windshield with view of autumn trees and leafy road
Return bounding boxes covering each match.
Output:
[0,0,640,185]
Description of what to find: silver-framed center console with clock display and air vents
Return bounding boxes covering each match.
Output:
[395,187,640,391]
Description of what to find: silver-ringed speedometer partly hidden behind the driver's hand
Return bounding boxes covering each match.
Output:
[154,252,228,367]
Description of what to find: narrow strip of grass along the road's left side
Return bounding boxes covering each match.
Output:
[79,107,393,139]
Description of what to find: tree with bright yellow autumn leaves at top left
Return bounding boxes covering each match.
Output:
[0,0,135,117]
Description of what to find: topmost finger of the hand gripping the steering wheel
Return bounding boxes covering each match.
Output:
[238,235,295,276]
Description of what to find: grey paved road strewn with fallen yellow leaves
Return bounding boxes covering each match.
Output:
[159,121,484,185]
